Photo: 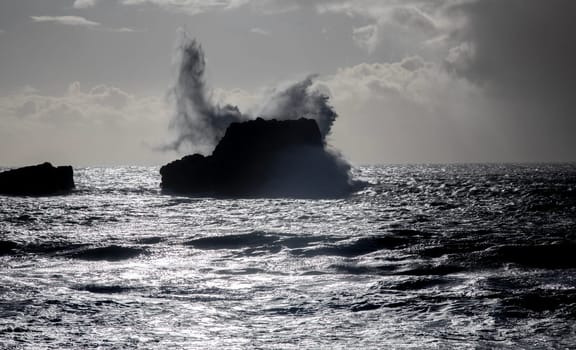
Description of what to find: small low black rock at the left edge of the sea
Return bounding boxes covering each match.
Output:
[0,163,74,196]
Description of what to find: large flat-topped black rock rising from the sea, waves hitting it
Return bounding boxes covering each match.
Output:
[160,118,352,198]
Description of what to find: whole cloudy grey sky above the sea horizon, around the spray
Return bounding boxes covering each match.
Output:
[0,0,576,166]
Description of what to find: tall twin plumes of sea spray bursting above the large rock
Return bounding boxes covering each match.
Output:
[166,32,337,153]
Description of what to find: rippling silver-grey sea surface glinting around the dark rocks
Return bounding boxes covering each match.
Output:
[0,164,576,349]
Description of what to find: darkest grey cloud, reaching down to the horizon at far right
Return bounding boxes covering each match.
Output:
[446,0,576,161]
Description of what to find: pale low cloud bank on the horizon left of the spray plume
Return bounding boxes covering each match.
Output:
[0,82,174,166]
